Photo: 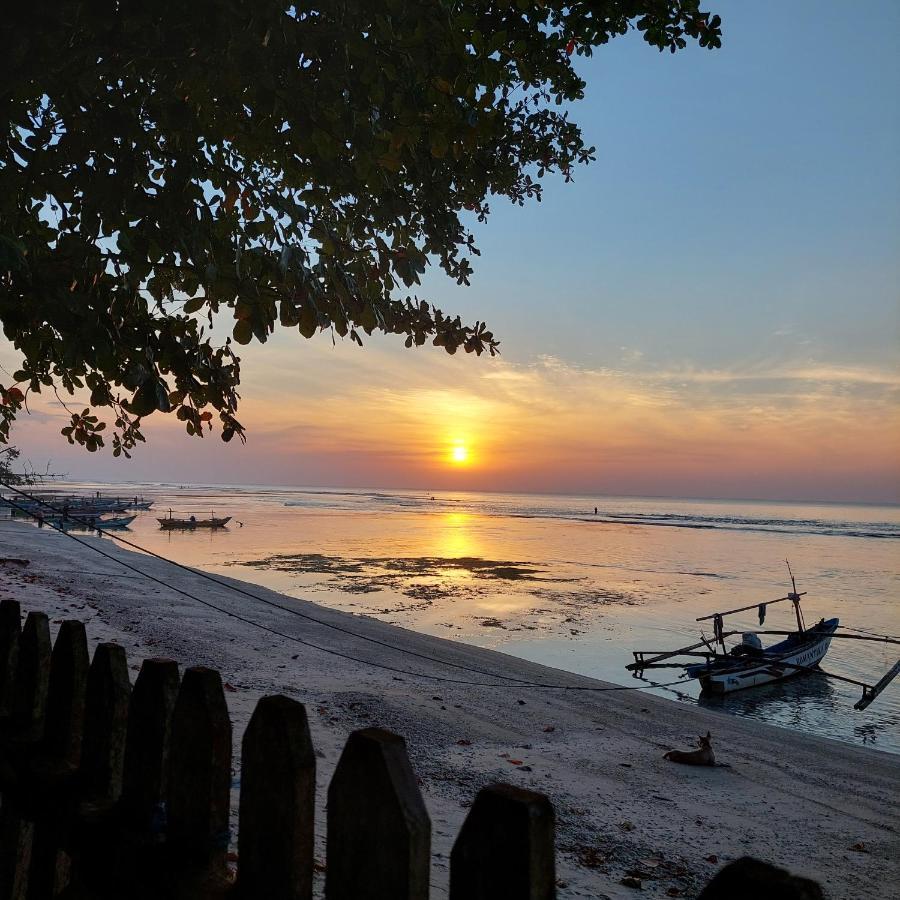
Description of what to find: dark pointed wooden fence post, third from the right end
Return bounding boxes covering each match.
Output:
[325,728,431,900]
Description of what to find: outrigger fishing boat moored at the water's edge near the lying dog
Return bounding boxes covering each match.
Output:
[626,564,900,710]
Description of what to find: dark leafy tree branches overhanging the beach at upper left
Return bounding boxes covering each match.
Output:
[0,0,721,455]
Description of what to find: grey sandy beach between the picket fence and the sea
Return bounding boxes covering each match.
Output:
[0,520,900,900]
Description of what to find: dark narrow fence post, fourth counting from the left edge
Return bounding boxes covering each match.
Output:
[81,644,131,804]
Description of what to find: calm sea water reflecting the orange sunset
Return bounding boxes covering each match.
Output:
[8,484,900,753]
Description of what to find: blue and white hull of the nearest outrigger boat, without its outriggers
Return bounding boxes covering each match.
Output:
[687,619,838,695]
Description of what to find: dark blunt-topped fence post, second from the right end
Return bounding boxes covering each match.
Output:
[450,784,556,900]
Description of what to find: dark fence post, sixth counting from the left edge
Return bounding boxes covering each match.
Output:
[167,666,231,880]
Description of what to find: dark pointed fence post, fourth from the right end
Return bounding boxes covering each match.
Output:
[238,695,316,900]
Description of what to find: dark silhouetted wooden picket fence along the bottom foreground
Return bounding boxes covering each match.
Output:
[0,600,824,900]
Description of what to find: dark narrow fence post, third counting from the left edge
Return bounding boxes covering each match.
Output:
[44,619,90,767]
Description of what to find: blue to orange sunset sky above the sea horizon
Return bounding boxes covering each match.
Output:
[0,0,900,503]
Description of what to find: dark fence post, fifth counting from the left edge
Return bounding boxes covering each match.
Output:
[122,659,178,832]
